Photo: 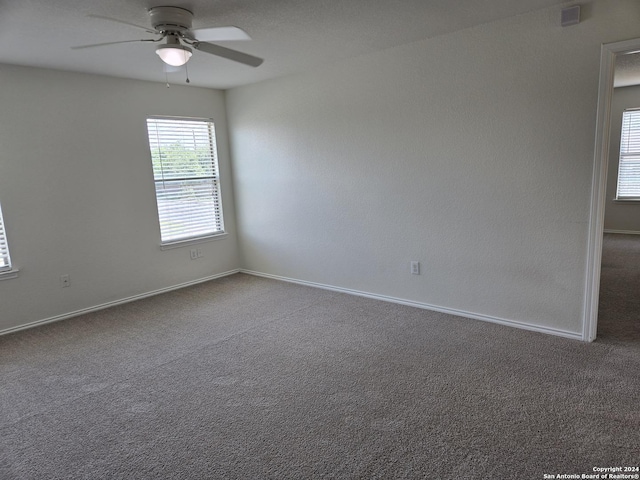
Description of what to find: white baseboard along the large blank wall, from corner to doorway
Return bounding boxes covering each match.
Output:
[240,269,584,341]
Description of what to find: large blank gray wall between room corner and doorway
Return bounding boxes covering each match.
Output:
[227,0,640,333]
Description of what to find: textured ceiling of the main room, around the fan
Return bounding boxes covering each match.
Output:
[0,0,580,88]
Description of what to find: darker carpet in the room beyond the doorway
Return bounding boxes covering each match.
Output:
[598,233,640,345]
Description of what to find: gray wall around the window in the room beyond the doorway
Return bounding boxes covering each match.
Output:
[604,86,640,233]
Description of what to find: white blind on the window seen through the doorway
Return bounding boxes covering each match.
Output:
[616,109,640,200]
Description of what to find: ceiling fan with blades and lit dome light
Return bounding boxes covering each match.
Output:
[71,7,264,67]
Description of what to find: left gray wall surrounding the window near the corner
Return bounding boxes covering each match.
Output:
[0,65,239,331]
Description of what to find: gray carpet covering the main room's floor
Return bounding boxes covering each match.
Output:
[0,274,640,480]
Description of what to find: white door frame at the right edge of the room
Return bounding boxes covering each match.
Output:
[582,38,640,342]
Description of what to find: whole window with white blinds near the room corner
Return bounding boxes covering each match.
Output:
[147,117,224,245]
